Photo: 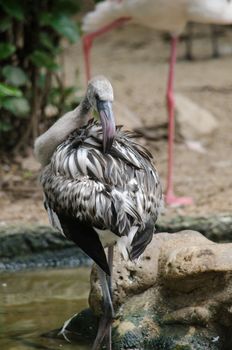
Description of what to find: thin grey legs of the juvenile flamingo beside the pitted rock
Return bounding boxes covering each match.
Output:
[92,267,114,350]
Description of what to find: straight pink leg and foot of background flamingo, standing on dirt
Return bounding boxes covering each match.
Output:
[166,37,193,206]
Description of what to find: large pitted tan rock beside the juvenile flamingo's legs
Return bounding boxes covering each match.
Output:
[86,230,232,350]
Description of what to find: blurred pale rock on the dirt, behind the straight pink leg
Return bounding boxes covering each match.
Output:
[175,94,218,141]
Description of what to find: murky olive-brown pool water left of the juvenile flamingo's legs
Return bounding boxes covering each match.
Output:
[0,268,90,350]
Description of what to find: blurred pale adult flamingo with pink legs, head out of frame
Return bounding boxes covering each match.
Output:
[83,0,232,205]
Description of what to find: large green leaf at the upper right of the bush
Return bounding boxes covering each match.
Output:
[41,13,79,43]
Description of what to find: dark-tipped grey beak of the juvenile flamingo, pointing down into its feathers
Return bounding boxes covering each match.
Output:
[97,100,116,153]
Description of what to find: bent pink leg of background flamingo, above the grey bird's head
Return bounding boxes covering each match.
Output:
[82,17,131,81]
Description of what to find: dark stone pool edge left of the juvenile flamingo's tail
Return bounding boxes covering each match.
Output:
[0,224,91,272]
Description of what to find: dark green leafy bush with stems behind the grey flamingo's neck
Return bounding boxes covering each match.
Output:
[0,0,80,151]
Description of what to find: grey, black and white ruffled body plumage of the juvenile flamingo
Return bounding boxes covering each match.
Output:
[41,120,162,252]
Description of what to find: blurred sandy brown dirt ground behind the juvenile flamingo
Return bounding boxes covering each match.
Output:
[0,26,232,225]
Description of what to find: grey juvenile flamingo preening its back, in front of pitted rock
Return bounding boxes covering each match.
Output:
[35,77,162,350]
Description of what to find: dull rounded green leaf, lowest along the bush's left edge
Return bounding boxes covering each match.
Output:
[2,97,30,117]
